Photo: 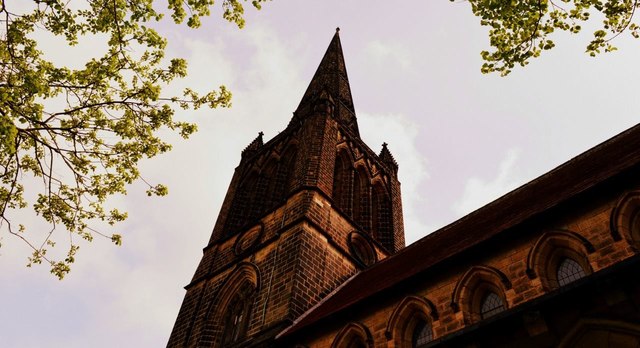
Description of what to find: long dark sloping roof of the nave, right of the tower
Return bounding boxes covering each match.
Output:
[278,124,640,338]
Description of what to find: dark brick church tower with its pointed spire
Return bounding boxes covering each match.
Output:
[168,30,404,347]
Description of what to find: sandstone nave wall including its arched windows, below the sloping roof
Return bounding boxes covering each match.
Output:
[283,182,640,347]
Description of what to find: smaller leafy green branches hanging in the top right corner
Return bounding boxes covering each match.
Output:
[464,0,640,75]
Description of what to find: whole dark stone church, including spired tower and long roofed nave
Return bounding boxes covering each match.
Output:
[167,31,640,348]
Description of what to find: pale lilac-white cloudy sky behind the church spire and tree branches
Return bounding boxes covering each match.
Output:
[0,0,640,347]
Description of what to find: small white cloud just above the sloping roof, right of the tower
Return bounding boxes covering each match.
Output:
[452,148,522,216]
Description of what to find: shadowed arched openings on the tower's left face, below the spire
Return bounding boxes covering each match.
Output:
[225,146,297,236]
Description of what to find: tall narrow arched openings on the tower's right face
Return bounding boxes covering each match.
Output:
[332,150,394,250]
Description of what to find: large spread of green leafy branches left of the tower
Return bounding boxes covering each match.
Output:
[0,0,265,279]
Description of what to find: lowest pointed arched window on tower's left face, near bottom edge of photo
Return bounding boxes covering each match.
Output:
[222,284,254,347]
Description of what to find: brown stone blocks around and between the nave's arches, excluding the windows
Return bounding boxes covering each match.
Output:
[293,181,637,348]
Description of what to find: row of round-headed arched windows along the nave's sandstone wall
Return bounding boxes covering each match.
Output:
[334,207,640,348]
